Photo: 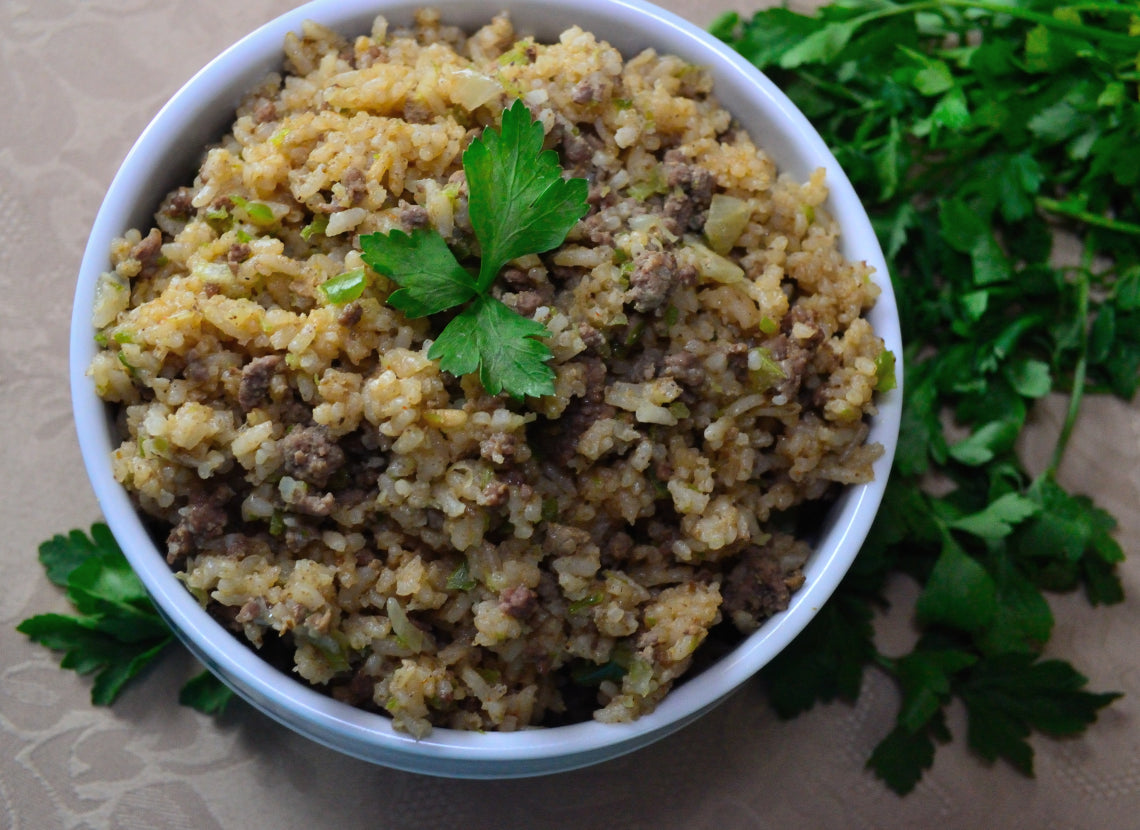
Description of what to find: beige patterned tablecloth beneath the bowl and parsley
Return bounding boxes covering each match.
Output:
[0,0,1140,830]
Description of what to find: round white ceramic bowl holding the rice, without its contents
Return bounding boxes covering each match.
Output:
[71,0,902,779]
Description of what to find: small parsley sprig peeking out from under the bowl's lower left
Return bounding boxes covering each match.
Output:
[16,524,231,715]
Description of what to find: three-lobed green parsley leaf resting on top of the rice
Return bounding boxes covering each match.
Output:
[357,100,589,398]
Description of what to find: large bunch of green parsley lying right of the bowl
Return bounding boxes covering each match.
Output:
[713,0,1140,792]
